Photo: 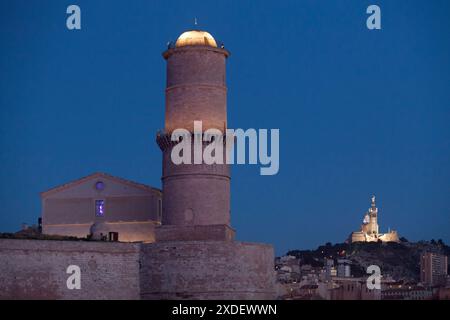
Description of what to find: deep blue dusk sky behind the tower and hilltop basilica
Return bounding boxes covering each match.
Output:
[0,0,450,254]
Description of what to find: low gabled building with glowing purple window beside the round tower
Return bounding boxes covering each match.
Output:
[41,173,162,242]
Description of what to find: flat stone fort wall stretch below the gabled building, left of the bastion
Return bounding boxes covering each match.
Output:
[0,239,140,300]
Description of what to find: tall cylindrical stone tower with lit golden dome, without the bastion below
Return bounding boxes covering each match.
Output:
[156,31,234,241]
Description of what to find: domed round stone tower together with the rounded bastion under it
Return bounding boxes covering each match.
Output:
[140,30,276,299]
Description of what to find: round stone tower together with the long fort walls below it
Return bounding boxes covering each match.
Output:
[0,30,275,299]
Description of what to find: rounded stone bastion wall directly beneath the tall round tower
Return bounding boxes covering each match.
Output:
[141,241,276,300]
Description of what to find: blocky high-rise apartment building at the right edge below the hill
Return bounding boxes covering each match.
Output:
[420,252,448,286]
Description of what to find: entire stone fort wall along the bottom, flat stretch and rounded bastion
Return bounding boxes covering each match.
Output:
[0,239,275,300]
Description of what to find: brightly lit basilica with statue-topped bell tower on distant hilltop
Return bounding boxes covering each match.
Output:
[347,196,399,243]
